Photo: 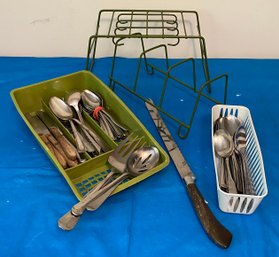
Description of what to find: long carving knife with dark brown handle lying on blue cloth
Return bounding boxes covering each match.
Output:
[145,99,232,248]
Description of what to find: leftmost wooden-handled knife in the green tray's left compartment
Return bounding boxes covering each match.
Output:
[25,113,67,169]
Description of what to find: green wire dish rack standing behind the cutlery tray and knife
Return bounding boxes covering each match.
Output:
[86,9,228,139]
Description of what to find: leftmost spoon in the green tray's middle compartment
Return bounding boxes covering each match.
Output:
[49,96,86,153]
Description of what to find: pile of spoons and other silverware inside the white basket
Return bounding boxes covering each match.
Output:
[213,110,255,195]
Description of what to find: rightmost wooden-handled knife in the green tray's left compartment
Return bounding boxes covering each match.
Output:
[37,111,77,161]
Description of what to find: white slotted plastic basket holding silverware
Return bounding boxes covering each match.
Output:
[211,105,268,214]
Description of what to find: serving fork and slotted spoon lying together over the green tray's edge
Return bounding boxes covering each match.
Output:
[58,134,160,230]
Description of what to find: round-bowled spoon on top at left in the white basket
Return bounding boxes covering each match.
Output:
[213,129,237,194]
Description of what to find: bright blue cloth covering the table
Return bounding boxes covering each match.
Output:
[0,57,279,257]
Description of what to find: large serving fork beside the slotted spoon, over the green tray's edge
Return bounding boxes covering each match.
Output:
[58,134,145,230]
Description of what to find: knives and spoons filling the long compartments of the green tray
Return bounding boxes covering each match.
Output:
[26,90,128,169]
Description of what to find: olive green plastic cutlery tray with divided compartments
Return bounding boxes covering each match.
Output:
[11,71,169,200]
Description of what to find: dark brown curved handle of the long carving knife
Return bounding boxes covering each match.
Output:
[187,183,232,248]
